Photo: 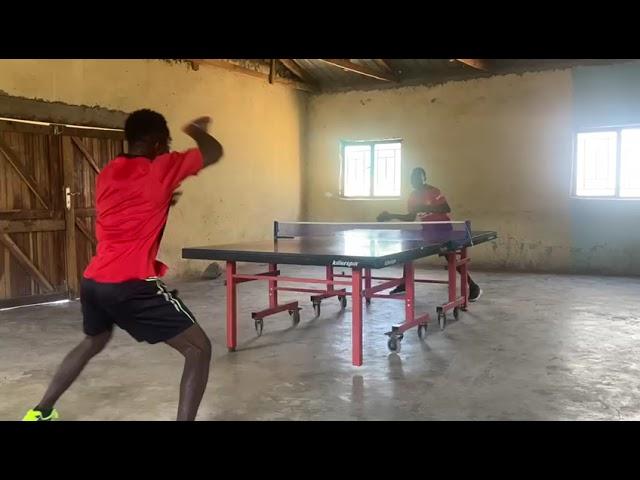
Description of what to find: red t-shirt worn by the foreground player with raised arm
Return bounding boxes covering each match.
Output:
[84,149,204,283]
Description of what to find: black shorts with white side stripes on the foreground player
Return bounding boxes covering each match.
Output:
[80,278,196,343]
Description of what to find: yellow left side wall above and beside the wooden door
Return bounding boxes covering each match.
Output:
[0,60,306,276]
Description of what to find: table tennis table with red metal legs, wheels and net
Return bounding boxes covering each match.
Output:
[182,221,498,366]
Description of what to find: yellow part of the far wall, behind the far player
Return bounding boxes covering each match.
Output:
[304,70,572,271]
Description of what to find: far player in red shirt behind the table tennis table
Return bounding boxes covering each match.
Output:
[378,167,482,302]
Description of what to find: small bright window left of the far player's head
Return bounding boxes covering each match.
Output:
[340,140,402,198]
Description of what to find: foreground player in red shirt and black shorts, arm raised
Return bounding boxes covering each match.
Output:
[24,110,223,421]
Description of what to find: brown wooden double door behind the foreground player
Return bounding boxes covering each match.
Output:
[0,121,124,308]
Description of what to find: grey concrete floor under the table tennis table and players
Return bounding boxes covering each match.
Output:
[0,267,640,420]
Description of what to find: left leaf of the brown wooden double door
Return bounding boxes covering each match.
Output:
[0,121,67,307]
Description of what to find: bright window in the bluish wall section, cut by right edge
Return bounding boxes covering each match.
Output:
[574,127,640,199]
